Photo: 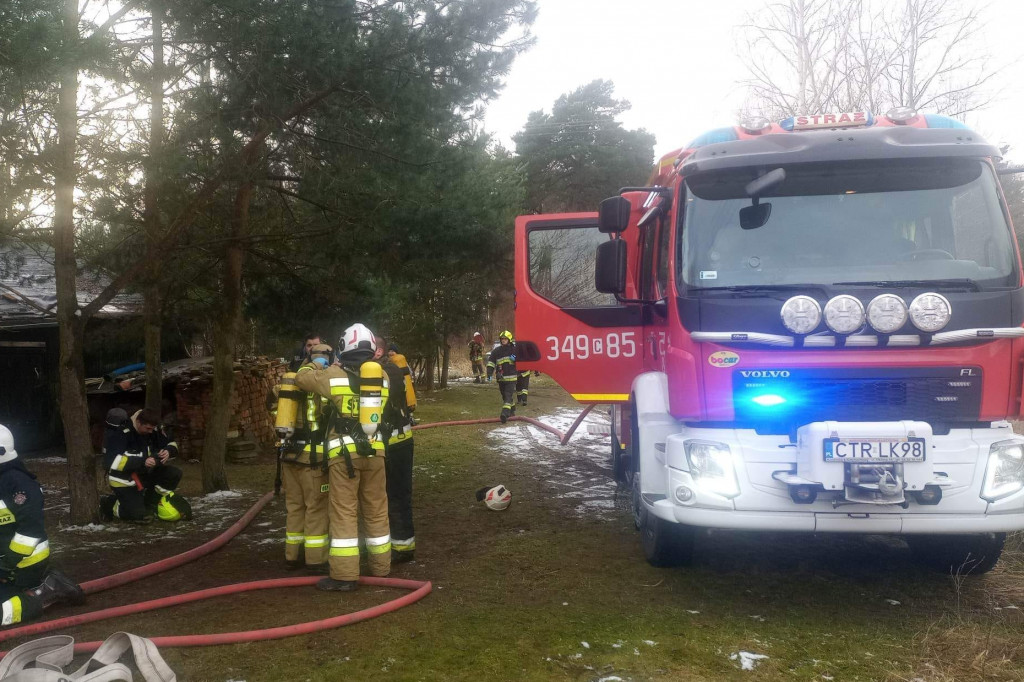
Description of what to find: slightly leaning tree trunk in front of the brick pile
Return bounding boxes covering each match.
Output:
[203,165,253,493]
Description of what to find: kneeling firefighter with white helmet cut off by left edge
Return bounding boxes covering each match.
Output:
[0,426,85,626]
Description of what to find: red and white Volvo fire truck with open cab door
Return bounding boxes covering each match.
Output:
[515,110,1024,572]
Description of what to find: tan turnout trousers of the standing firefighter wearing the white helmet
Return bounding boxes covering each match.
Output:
[328,457,391,581]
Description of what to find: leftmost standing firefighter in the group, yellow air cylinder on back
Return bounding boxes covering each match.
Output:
[274,344,334,572]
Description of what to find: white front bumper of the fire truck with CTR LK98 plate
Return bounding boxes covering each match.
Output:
[643,422,1024,535]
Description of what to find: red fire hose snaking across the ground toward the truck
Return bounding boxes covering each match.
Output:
[0,406,593,658]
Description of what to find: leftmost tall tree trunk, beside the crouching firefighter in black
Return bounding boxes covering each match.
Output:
[53,0,99,523]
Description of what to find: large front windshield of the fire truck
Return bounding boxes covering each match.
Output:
[679,159,1017,290]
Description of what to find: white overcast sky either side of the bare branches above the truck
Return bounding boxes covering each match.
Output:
[485,0,1024,163]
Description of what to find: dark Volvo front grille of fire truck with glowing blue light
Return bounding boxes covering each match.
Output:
[732,367,982,426]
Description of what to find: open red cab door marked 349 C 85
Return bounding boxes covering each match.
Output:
[515,213,643,403]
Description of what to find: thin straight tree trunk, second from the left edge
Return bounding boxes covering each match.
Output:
[142,0,164,413]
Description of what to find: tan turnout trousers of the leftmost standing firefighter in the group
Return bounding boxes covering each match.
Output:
[281,462,330,566]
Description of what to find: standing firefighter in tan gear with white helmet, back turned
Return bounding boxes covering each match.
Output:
[295,324,391,592]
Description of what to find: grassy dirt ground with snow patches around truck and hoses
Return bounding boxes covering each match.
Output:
[14,377,1024,682]
